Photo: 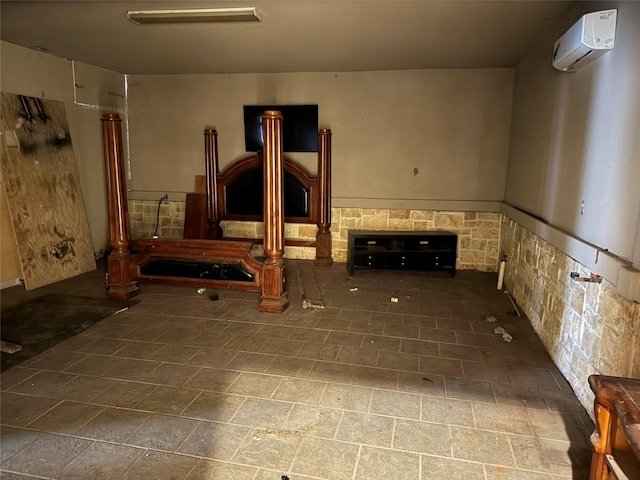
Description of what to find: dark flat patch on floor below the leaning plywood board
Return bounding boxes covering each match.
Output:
[0,294,138,372]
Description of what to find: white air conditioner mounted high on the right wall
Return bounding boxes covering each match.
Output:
[553,9,617,71]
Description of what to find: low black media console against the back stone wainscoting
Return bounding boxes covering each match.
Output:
[347,230,458,275]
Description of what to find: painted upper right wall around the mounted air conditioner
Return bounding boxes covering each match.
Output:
[505,2,640,262]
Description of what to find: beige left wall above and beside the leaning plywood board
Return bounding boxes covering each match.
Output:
[0,42,124,262]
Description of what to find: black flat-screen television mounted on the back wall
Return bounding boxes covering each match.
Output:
[244,105,318,152]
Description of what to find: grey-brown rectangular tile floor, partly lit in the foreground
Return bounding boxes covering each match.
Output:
[0,261,593,480]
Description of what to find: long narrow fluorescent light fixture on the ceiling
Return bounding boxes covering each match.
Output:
[127,7,262,24]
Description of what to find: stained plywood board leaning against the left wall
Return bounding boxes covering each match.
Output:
[0,92,96,290]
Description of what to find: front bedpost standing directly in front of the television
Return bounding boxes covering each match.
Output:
[258,110,289,313]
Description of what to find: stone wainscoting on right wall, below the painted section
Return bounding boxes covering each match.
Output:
[501,216,640,414]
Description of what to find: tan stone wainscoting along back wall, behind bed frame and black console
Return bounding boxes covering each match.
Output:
[129,200,500,272]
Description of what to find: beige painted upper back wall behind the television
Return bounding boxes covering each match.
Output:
[128,69,513,211]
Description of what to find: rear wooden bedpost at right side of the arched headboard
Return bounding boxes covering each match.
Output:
[313,128,333,267]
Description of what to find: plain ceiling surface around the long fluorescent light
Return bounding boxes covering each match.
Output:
[0,0,575,74]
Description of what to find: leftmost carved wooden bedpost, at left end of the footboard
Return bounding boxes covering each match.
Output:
[102,113,140,299]
